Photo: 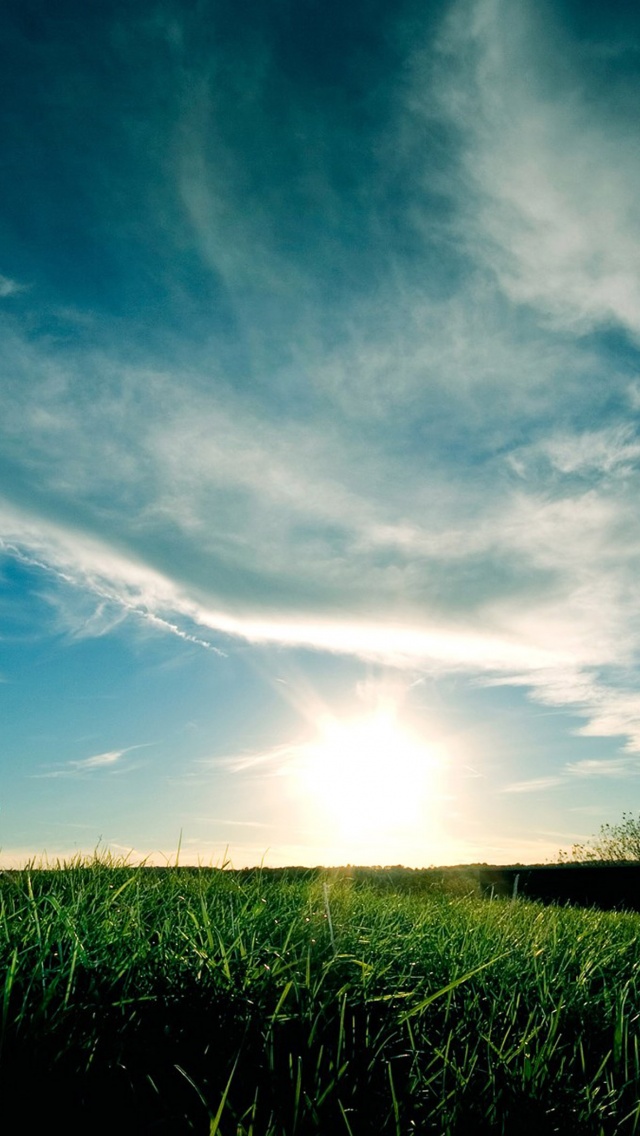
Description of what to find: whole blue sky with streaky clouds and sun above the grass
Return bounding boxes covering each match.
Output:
[0,0,640,867]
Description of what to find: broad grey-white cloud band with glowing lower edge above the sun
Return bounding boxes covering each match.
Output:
[3,331,638,745]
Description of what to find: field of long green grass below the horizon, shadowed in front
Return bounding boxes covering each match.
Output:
[0,858,640,1136]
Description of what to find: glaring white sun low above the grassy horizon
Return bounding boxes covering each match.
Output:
[300,710,440,836]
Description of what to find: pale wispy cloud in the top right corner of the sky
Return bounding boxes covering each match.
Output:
[440,0,640,337]
